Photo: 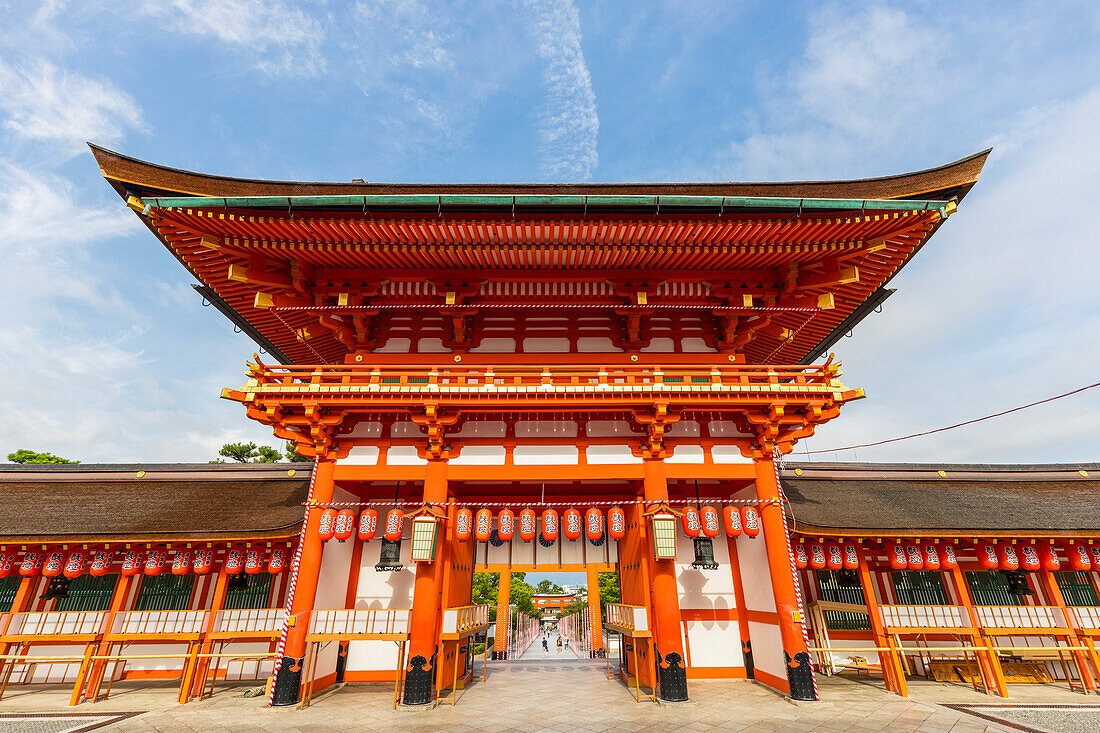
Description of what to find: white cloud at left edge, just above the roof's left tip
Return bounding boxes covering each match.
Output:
[0,58,143,157]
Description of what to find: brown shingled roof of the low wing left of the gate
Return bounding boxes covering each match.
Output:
[0,463,312,544]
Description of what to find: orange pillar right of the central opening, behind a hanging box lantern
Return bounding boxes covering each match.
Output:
[635,459,688,702]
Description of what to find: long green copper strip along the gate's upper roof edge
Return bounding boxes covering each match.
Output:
[141,194,954,215]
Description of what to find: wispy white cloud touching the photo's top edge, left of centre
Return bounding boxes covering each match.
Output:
[144,0,326,77]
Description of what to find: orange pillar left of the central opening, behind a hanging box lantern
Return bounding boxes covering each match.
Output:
[405,459,447,705]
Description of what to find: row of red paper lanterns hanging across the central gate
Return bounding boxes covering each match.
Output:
[317,504,761,543]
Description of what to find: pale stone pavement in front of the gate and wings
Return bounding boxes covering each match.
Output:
[0,659,1097,733]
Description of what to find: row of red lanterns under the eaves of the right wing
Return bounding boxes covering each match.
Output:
[792,539,1100,571]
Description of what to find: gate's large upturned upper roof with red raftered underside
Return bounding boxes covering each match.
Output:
[92,145,989,363]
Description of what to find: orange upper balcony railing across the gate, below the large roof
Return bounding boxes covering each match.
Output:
[241,360,845,394]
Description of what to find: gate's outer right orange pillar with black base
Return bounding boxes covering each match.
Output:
[754,456,817,700]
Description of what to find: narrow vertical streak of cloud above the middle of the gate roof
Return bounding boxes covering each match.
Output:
[525,0,600,180]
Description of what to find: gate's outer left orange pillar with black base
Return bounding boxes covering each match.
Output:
[272,459,336,705]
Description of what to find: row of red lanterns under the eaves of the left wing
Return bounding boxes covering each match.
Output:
[0,544,290,579]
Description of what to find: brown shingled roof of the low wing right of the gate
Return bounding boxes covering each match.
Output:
[781,463,1100,537]
